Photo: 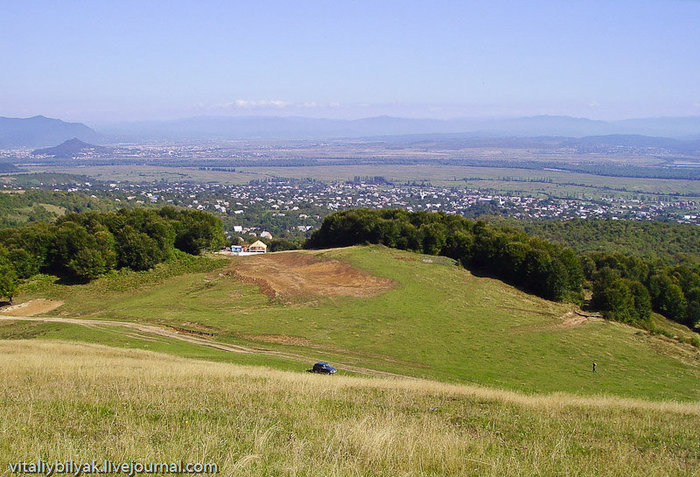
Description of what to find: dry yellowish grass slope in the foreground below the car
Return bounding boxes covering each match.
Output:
[0,341,700,477]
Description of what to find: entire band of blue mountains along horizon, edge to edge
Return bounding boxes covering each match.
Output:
[0,116,700,148]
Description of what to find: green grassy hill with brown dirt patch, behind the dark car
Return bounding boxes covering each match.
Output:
[10,246,700,400]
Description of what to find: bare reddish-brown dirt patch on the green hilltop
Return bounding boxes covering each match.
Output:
[231,252,396,298]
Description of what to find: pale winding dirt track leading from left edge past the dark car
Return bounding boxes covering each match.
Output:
[0,315,418,379]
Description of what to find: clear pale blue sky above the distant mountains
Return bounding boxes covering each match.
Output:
[0,0,700,121]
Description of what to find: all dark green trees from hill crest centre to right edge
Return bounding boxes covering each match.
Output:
[305,209,700,328]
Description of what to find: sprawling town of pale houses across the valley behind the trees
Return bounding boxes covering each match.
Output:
[90,179,700,225]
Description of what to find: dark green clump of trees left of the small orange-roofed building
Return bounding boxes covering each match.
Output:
[0,207,224,300]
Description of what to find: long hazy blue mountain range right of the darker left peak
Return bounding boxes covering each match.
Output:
[99,116,700,142]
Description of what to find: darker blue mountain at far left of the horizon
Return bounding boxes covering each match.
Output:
[0,116,102,148]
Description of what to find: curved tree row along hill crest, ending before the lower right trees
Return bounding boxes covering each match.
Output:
[305,209,584,302]
